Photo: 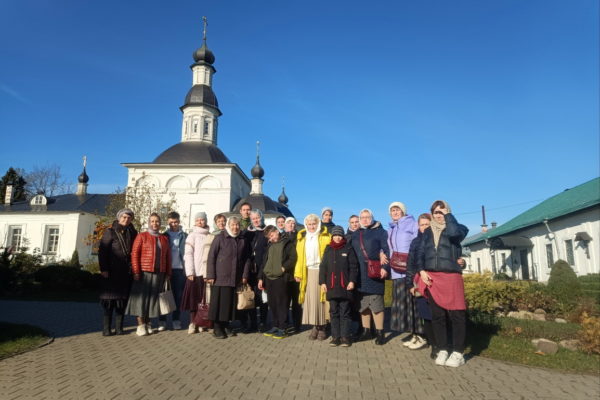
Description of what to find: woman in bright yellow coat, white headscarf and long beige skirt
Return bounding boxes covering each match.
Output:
[294,214,331,340]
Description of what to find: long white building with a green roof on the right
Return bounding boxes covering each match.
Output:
[462,178,600,282]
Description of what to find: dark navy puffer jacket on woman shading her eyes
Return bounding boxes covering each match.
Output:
[416,213,469,273]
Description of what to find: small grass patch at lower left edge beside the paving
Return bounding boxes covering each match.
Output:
[0,322,49,359]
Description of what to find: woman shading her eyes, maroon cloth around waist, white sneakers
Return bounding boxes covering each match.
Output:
[417,200,469,367]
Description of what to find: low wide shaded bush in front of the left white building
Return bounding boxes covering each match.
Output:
[35,265,98,291]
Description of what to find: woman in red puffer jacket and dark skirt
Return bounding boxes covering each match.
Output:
[127,213,171,336]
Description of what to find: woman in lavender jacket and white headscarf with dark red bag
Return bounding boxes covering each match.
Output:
[388,201,424,345]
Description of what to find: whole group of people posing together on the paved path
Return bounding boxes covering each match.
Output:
[98,200,468,367]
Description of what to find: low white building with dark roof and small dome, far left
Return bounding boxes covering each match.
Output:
[0,166,110,264]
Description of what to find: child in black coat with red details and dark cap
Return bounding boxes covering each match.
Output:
[319,226,358,347]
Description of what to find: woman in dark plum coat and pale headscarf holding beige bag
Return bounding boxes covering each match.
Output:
[206,217,250,339]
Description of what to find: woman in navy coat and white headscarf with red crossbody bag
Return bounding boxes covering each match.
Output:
[352,208,390,345]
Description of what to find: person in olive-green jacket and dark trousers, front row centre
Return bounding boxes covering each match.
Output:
[258,225,296,339]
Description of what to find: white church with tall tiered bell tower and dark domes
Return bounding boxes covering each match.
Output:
[123,27,291,229]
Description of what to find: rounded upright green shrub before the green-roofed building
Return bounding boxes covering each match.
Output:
[548,260,583,313]
